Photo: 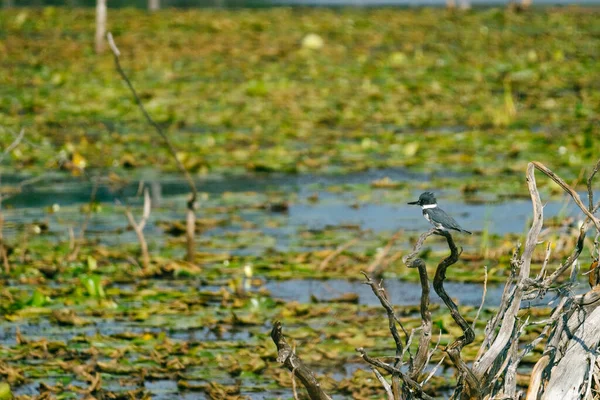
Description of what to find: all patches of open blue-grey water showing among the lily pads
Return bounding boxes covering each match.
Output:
[0,170,583,400]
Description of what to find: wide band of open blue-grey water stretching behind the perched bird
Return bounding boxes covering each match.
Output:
[3,170,585,242]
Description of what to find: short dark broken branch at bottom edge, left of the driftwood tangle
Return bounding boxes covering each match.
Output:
[271,321,331,400]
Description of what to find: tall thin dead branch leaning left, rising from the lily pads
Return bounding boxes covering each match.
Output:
[106,32,198,262]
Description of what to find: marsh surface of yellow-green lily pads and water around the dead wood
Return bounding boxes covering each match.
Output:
[0,7,600,400]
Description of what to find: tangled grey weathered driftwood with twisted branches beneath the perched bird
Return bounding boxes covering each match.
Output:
[270,161,600,400]
